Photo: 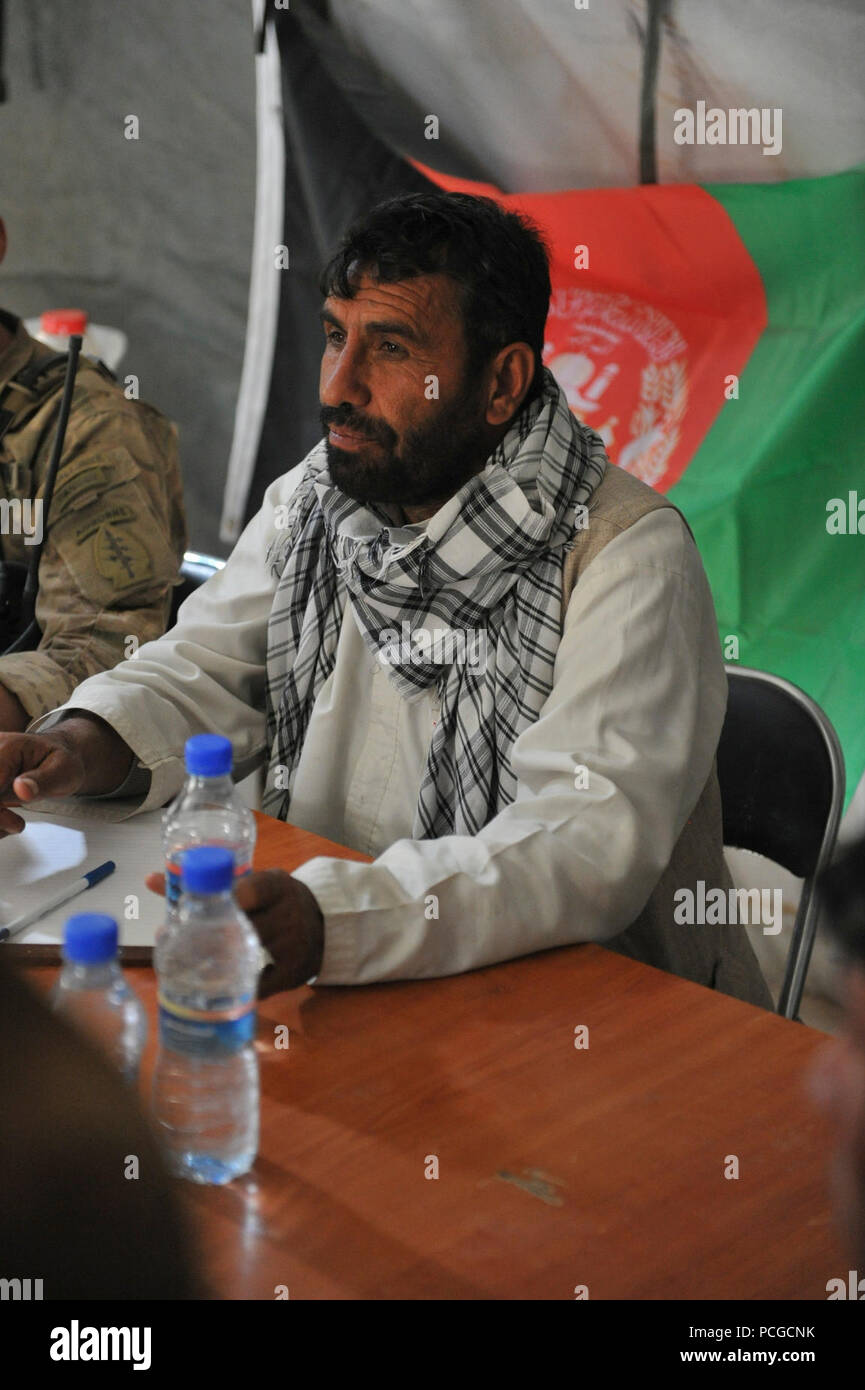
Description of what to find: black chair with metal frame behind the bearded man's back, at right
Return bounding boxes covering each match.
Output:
[718,666,844,1019]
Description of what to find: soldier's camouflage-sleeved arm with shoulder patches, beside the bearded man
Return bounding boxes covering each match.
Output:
[0,403,186,728]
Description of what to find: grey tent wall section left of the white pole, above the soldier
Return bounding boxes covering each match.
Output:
[0,0,256,553]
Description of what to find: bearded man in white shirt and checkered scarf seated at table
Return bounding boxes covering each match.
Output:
[0,193,770,1008]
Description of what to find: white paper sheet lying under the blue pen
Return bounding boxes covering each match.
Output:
[0,808,164,951]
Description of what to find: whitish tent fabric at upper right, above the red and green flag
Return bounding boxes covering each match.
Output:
[331,0,865,192]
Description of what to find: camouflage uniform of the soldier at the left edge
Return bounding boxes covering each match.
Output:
[0,314,186,719]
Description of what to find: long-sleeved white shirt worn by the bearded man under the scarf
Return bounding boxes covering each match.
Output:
[32,466,726,984]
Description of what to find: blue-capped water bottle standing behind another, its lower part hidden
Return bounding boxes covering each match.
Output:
[163,734,256,922]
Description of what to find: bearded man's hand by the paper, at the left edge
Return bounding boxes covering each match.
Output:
[0,713,135,840]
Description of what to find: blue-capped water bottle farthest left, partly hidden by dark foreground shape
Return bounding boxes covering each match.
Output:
[51,912,147,1083]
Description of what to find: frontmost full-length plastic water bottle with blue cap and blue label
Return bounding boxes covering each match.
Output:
[153,848,259,1183]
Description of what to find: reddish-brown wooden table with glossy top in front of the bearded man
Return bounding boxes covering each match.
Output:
[25,817,848,1300]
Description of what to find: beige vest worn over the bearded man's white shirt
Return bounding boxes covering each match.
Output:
[562,464,773,1009]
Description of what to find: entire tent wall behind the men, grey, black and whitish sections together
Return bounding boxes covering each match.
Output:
[0,0,865,553]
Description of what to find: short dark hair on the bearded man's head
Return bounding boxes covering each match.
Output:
[318,193,551,403]
